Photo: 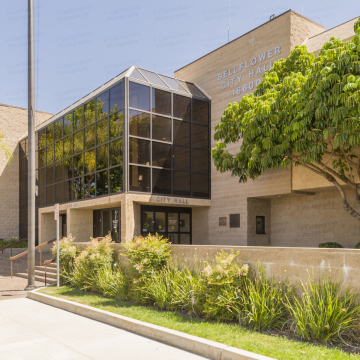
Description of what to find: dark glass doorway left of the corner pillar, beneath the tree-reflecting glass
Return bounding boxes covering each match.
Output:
[93,208,121,243]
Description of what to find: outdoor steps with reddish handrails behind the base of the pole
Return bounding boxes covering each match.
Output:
[0,249,56,285]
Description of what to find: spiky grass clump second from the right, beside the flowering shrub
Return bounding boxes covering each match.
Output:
[238,265,294,331]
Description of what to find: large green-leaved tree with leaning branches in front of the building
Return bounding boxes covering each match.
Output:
[212,18,360,221]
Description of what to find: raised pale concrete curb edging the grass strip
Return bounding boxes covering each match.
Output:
[27,290,275,360]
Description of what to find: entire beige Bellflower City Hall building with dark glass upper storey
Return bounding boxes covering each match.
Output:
[0,10,360,247]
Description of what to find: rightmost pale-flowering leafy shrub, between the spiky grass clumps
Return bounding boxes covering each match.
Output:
[202,250,249,321]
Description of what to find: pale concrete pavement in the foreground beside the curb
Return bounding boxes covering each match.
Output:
[0,299,210,360]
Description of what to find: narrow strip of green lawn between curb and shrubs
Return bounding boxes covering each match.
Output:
[39,286,360,360]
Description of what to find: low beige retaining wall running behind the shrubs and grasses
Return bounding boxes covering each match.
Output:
[171,245,360,292]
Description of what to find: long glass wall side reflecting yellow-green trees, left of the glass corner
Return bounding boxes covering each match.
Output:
[38,82,124,207]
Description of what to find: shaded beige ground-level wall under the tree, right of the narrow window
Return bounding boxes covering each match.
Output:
[271,187,360,248]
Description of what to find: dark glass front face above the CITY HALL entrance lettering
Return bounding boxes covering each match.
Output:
[128,77,210,198]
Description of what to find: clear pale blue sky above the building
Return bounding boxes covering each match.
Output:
[0,0,360,113]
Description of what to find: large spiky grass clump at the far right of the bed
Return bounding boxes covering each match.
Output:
[287,275,360,342]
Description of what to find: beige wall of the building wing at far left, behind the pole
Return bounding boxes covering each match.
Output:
[0,104,51,238]
